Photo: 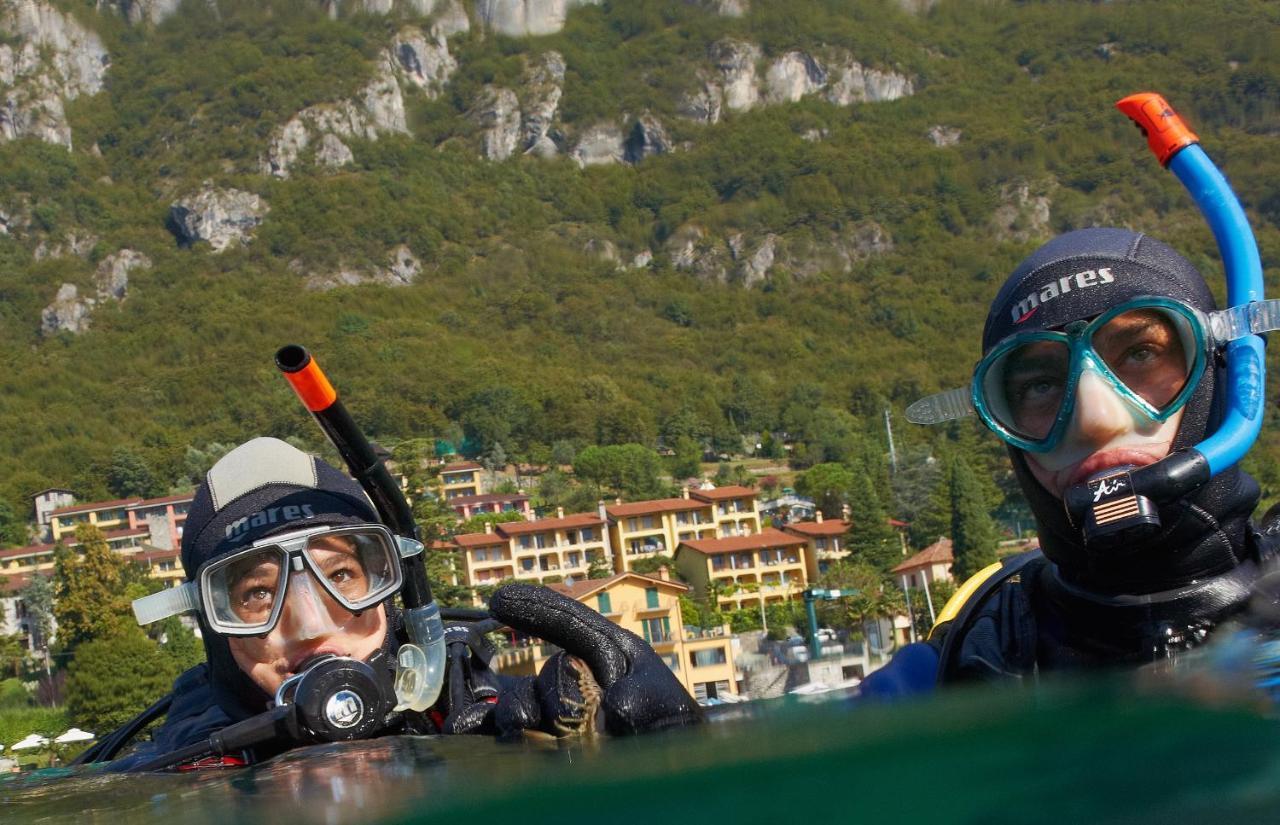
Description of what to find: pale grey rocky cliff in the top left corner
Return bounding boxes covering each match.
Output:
[0,0,110,148]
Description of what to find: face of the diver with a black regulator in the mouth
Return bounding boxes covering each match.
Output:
[228,537,387,695]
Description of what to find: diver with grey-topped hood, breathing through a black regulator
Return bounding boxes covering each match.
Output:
[90,439,701,770]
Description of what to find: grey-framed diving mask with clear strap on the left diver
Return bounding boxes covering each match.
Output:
[133,524,422,636]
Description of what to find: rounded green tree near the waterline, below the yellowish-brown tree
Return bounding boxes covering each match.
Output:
[67,627,182,732]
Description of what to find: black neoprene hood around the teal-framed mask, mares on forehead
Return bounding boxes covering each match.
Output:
[982,228,1258,593]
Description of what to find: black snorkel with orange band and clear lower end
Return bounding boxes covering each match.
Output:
[275,344,445,712]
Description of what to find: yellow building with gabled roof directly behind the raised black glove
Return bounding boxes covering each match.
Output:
[497,570,739,700]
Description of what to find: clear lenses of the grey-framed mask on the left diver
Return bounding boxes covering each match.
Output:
[201,528,402,634]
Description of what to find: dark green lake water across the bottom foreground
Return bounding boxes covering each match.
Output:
[0,679,1280,825]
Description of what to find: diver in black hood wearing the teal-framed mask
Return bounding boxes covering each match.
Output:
[863,228,1280,696]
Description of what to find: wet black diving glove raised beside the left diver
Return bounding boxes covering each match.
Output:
[445,585,703,737]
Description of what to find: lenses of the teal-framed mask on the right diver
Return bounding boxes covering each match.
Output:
[980,307,1198,443]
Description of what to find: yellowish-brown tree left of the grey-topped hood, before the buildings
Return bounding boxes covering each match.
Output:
[54,524,132,651]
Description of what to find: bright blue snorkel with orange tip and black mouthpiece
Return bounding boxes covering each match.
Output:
[1064,92,1266,545]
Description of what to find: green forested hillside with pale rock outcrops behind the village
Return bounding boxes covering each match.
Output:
[0,0,1280,537]
